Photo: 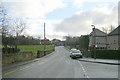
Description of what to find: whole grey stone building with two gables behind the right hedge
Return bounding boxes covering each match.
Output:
[89,25,120,50]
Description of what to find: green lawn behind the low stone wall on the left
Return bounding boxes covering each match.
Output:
[18,45,54,53]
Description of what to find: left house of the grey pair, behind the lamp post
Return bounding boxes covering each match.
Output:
[89,28,107,49]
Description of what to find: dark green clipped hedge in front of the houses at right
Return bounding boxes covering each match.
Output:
[91,50,120,60]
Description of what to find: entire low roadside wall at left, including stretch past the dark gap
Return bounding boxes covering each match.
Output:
[2,49,54,66]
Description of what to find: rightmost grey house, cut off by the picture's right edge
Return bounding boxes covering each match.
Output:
[107,25,120,50]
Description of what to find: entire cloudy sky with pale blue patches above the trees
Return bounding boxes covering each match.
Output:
[1,0,119,40]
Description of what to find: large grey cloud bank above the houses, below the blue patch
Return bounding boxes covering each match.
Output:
[56,3,118,36]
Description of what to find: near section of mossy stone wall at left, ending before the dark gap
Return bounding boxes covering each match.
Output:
[2,52,35,66]
